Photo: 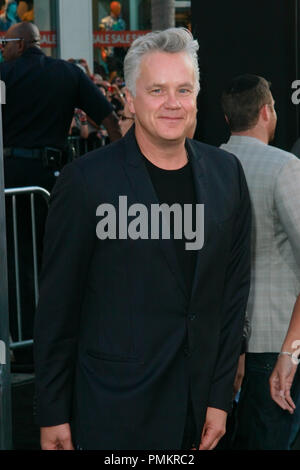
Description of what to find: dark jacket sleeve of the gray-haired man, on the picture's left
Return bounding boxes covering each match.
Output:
[34,163,96,426]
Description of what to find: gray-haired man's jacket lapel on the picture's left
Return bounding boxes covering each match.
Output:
[124,126,188,297]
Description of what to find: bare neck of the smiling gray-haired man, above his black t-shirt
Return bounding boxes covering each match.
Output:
[135,127,188,170]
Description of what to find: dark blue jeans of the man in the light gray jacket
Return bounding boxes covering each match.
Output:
[234,353,300,450]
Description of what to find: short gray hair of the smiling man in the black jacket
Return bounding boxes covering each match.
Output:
[124,28,200,96]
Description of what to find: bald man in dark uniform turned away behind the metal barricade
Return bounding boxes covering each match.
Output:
[0,22,121,364]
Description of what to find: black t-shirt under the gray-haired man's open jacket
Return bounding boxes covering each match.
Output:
[144,157,196,294]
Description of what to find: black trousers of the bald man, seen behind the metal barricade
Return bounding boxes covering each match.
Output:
[4,157,56,364]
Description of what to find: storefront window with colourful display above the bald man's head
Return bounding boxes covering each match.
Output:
[0,0,57,57]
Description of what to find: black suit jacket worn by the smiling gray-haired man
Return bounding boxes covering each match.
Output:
[35,129,250,449]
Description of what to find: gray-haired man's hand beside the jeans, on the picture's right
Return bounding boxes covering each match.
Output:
[199,407,227,450]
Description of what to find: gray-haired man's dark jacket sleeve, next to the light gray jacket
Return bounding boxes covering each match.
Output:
[208,161,251,412]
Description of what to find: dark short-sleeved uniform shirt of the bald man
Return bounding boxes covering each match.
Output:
[0,47,113,149]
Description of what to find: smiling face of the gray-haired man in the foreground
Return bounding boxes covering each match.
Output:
[128,52,197,145]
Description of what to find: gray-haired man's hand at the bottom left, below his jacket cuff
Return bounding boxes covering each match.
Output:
[41,423,74,450]
